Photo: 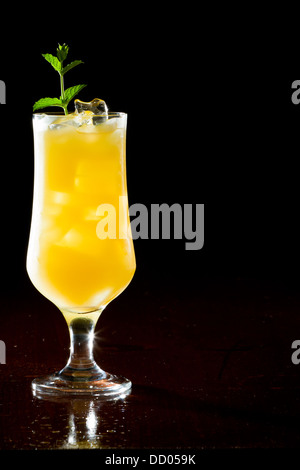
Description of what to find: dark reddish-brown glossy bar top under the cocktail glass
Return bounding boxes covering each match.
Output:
[0,279,300,450]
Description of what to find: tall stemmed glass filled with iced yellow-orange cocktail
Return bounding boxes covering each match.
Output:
[27,113,135,396]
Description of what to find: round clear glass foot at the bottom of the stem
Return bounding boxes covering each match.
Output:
[31,372,132,398]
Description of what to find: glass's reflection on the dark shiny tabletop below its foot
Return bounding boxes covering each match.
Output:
[32,391,130,449]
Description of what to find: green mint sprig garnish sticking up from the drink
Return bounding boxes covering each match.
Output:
[33,44,86,114]
